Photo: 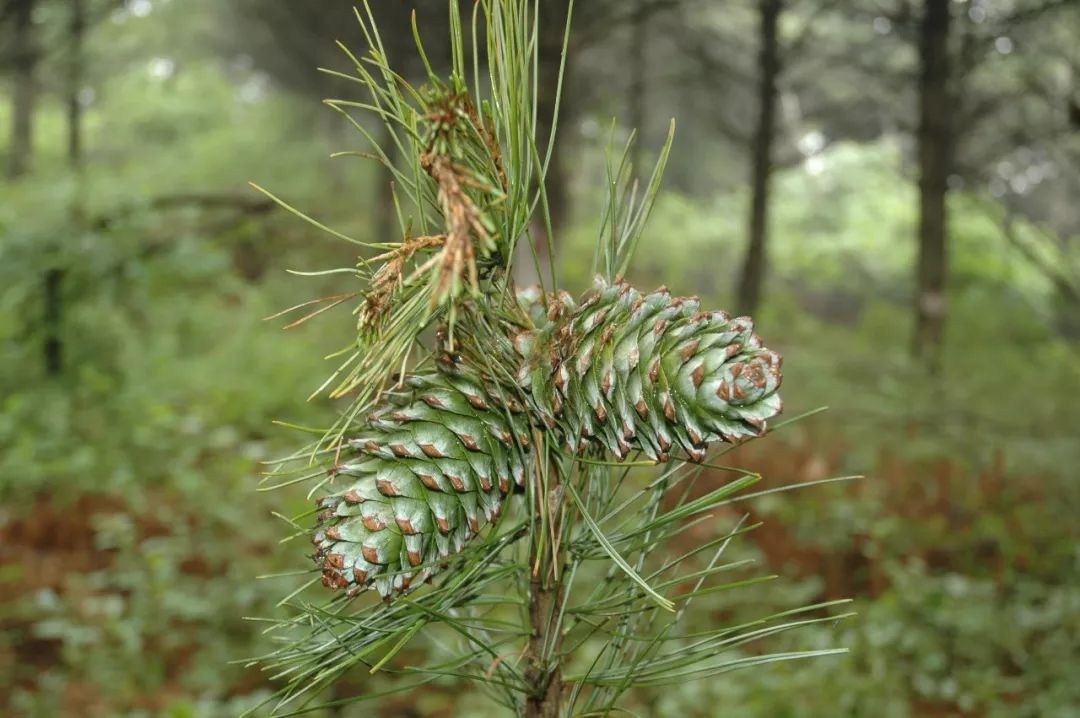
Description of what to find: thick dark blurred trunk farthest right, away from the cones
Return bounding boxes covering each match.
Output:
[914,0,954,370]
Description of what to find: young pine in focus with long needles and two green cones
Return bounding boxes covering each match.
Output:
[248,0,836,718]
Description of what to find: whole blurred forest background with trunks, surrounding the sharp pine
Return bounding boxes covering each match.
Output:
[0,0,1080,717]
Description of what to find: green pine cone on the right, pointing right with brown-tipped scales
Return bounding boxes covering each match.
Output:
[514,277,782,461]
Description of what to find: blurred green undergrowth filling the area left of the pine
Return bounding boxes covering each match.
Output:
[0,7,366,717]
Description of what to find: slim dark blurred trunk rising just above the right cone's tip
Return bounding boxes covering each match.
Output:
[737,0,783,314]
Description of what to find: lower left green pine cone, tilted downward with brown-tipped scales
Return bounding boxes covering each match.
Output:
[313,372,529,598]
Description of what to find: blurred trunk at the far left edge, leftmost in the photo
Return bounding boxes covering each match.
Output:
[8,0,39,179]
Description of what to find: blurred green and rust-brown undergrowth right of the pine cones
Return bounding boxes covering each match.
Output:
[548,136,1080,716]
